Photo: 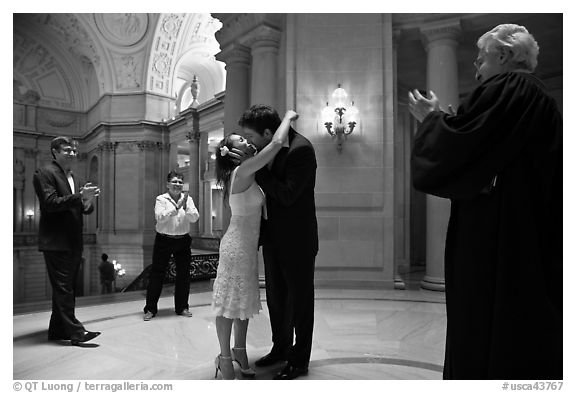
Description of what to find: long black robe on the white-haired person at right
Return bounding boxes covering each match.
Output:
[412,72,562,379]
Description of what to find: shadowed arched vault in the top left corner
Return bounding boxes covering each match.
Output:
[13,14,105,110]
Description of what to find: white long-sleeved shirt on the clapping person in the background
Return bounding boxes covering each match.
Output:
[154,193,200,236]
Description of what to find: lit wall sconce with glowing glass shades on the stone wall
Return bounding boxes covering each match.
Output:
[322,84,358,153]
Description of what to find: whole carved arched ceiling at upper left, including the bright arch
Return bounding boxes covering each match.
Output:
[13,13,225,111]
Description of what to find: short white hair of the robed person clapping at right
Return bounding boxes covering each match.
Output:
[476,24,540,72]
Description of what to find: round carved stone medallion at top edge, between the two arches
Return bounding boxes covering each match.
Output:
[95,13,149,46]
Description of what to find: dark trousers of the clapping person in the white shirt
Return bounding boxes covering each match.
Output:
[144,233,192,314]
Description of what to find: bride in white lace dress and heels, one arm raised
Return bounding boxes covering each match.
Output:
[212,110,298,379]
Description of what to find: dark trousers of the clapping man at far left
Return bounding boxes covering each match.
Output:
[43,250,85,339]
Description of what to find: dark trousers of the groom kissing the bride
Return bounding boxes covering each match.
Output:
[263,246,316,368]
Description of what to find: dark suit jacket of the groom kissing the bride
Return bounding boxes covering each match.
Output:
[256,129,318,257]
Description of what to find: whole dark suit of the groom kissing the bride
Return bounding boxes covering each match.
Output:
[256,129,318,368]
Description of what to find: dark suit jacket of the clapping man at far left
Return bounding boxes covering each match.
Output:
[34,161,94,251]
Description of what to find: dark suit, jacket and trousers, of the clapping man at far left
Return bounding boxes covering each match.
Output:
[34,161,94,339]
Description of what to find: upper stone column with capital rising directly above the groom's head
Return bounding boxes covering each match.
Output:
[241,25,280,108]
